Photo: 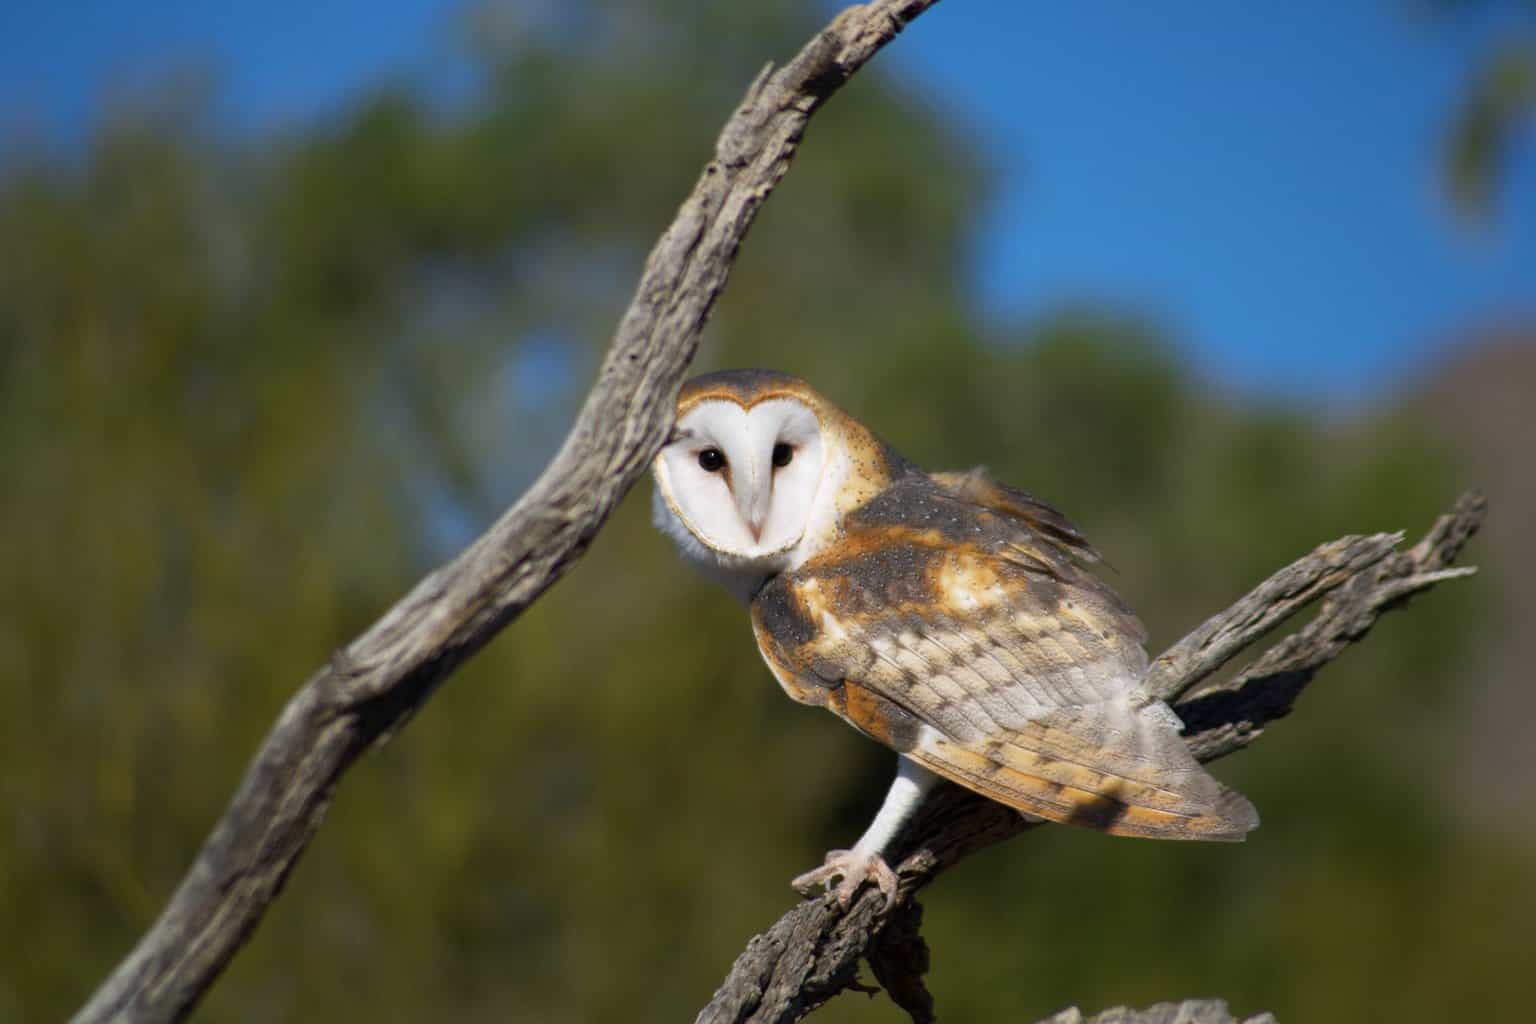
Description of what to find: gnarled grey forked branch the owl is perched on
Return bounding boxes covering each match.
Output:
[697,493,1487,1024]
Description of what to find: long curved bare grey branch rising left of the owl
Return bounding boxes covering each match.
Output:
[75,0,937,1022]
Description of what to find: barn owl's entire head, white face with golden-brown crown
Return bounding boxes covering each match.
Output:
[651,370,886,590]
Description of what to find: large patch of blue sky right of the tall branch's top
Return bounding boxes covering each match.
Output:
[902,0,1536,404]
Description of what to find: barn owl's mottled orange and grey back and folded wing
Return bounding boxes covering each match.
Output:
[753,473,1258,840]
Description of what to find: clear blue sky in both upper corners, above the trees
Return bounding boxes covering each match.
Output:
[0,0,1536,405]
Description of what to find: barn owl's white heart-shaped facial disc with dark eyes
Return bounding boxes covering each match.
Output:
[654,398,825,565]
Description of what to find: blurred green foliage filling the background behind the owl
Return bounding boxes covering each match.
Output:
[0,0,1517,1022]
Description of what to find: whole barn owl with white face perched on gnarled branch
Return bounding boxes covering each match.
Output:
[653,370,1258,906]
